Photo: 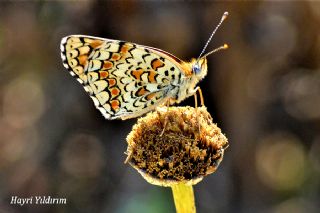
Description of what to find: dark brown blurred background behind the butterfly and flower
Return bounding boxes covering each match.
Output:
[0,1,320,213]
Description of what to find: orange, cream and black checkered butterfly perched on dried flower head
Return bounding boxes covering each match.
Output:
[60,12,228,120]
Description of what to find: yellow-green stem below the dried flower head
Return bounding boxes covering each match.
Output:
[171,183,196,213]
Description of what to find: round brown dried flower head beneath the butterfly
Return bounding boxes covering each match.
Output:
[127,107,228,186]
